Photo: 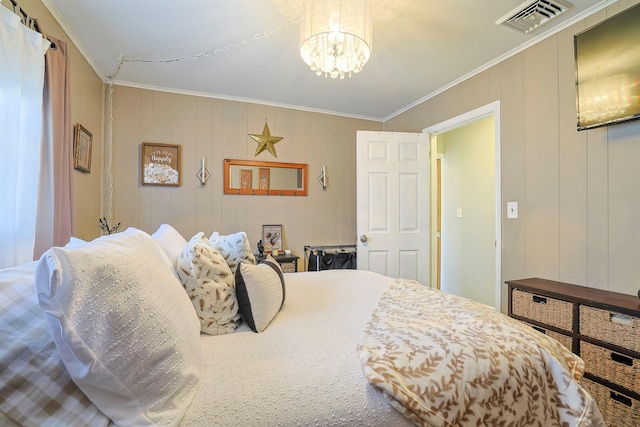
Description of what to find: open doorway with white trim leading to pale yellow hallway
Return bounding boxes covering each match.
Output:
[424,101,501,310]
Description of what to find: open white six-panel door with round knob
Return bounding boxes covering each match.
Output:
[356,131,431,285]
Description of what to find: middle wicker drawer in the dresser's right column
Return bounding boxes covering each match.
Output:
[580,341,640,390]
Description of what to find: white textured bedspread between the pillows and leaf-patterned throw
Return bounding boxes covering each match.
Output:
[182,270,411,426]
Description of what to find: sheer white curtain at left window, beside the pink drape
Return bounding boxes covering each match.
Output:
[0,7,49,268]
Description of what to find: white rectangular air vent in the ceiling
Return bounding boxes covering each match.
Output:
[496,0,573,34]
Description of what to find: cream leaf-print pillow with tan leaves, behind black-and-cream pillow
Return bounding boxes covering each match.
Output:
[178,232,240,335]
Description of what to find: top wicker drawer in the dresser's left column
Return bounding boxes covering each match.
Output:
[511,289,573,332]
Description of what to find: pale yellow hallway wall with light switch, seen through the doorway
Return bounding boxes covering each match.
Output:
[438,116,496,307]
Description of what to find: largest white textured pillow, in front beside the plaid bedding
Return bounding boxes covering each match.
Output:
[36,228,201,426]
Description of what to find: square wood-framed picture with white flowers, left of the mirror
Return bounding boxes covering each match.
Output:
[140,142,182,186]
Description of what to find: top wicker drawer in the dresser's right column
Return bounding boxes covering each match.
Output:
[580,305,640,353]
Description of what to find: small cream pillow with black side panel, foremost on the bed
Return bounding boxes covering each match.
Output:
[236,255,285,332]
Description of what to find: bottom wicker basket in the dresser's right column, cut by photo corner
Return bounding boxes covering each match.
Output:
[582,378,640,427]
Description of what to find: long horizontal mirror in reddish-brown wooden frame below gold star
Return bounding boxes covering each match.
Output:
[224,159,308,196]
